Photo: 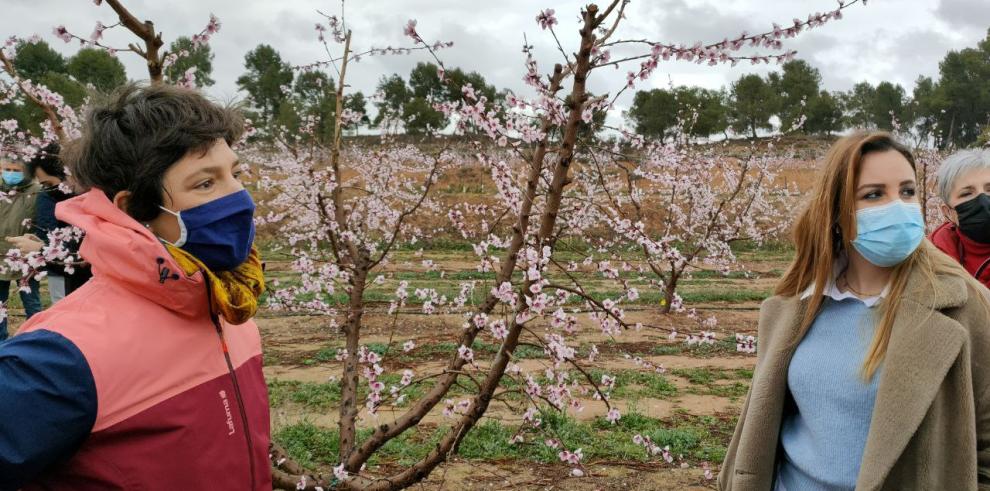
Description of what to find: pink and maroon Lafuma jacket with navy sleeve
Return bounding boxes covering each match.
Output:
[0,190,272,490]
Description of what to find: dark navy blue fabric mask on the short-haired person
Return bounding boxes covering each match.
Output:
[160,190,254,271]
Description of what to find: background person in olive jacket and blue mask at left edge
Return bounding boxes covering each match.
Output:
[0,160,41,341]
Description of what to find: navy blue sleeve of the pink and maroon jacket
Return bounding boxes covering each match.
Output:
[0,330,97,491]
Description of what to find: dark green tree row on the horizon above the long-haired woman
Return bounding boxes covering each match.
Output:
[626,27,990,148]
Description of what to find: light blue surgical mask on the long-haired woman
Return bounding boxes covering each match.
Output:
[852,200,925,268]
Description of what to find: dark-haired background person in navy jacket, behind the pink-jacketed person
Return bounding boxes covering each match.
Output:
[10,143,92,304]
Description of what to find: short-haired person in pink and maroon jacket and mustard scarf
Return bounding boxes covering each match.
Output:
[0,85,272,491]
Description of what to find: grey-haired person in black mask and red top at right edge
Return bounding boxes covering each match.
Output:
[931,149,990,287]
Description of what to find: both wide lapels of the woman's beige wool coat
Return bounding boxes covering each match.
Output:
[735,264,968,489]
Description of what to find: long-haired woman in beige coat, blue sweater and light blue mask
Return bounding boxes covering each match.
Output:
[719,132,990,491]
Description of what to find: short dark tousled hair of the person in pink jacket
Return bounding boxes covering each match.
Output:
[61,83,244,222]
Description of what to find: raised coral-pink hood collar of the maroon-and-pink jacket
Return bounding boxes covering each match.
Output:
[55,189,208,317]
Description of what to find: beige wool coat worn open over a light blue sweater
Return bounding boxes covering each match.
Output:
[718,272,990,491]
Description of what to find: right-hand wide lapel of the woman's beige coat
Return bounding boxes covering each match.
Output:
[856,273,967,490]
